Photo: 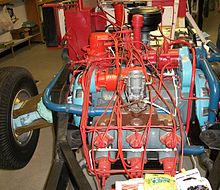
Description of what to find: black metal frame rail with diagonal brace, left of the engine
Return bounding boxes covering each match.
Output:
[44,65,92,190]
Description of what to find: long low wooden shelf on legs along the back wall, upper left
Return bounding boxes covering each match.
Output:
[0,33,40,57]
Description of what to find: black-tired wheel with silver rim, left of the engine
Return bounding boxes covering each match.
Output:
[0,67,39,169]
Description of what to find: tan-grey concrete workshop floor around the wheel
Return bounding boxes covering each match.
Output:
[0,11,220,190]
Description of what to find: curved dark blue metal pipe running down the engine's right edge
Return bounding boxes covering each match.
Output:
[197,58,220,124]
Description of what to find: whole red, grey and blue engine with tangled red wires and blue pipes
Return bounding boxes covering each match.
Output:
[43,3,219,189]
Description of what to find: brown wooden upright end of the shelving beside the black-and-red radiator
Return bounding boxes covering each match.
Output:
[25,0,54,42]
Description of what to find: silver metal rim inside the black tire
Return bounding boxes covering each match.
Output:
[11,89,33,146]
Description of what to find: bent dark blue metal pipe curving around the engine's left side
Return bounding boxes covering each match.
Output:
[42,65,112,117]
